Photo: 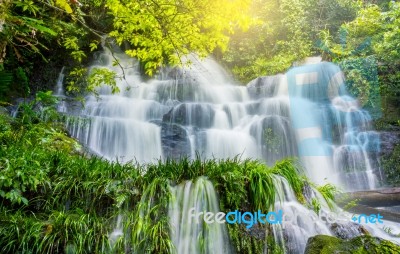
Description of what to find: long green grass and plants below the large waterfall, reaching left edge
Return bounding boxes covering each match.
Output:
[0,98,338,253]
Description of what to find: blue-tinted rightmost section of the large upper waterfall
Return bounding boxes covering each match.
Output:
[286,62,380,190]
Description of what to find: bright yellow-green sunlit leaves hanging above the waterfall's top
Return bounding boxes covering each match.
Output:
[107,0,248,75]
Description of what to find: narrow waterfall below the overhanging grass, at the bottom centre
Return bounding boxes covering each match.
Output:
[168,177,232,254]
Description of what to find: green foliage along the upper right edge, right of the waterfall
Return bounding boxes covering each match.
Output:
[320,1,400,122]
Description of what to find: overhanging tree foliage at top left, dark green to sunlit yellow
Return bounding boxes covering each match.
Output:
[0,0,248,98]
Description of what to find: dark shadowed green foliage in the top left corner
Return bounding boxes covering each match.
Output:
[0,0,103,97]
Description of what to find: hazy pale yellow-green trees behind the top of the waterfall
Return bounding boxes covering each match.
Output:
[223,0,361,82]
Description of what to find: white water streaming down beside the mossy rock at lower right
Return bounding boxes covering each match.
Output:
[271,176,399,254]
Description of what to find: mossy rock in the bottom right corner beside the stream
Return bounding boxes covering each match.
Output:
[304,235,400,254]
